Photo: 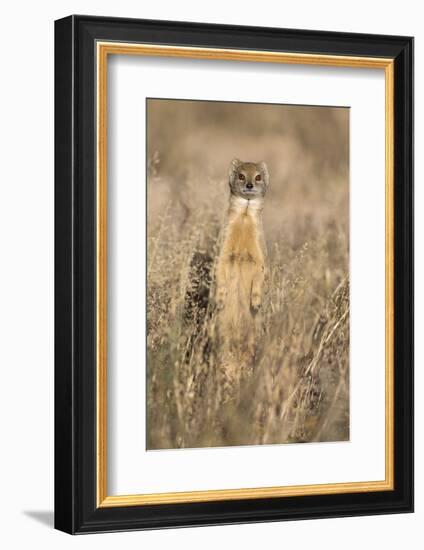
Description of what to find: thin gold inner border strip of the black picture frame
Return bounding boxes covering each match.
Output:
[96,41,394,507]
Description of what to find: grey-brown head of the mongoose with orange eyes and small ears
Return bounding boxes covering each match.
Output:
[229,159,269,200]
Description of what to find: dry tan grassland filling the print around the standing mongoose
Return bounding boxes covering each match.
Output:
[147,101,349,449]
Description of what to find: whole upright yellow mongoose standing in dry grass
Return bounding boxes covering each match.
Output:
[216,159,269,386]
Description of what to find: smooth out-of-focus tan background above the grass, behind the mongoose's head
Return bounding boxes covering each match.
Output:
[147,99,349,251]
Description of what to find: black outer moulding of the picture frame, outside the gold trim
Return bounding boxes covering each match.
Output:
[55,15,413,534]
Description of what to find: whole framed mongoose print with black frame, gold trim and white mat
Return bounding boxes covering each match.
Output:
[55,16,413,534]
